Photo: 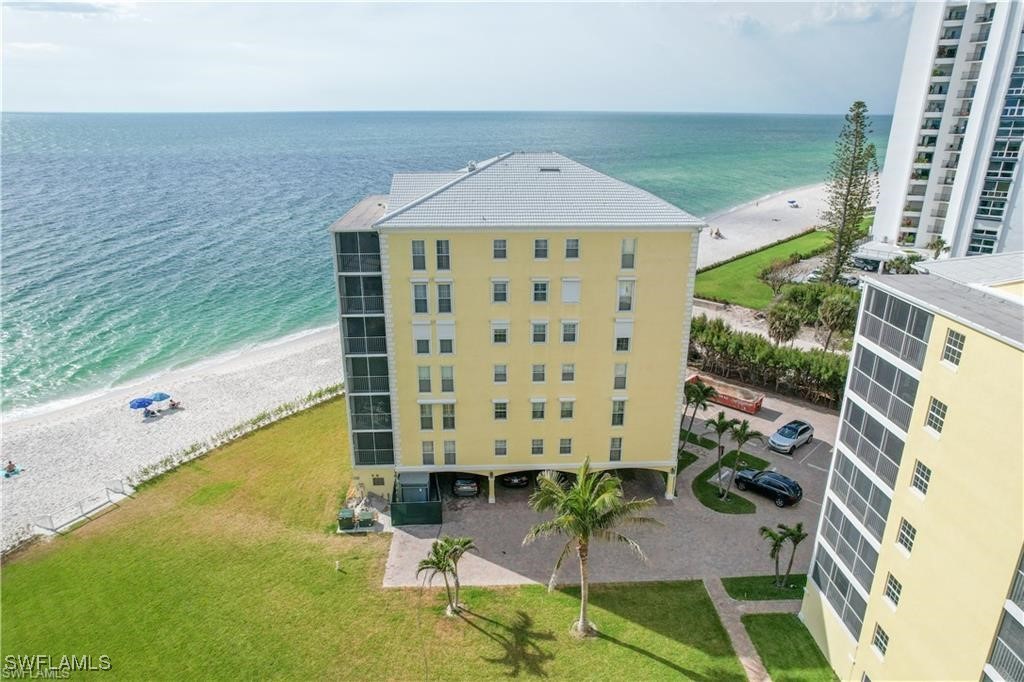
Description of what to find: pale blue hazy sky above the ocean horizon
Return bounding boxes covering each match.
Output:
[2,2,911,114]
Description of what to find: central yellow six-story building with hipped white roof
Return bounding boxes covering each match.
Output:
[332,153,702,502]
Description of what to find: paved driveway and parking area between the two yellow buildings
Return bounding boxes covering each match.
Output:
[384,387,837,587]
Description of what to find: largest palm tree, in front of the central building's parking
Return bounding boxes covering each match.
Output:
[522,458,660,637]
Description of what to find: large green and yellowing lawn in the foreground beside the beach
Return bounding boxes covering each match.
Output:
[0,399,744,682]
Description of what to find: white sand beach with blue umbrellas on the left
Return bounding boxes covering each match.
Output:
[0,327,342,549]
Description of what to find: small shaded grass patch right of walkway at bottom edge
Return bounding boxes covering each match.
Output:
[742,613,838,682]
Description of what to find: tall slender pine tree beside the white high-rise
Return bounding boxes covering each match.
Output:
[821,100,879,282]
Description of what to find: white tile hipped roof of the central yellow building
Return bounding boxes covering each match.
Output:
[374,152,703,228]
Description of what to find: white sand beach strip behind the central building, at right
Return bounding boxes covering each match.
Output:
[697,183,825,267]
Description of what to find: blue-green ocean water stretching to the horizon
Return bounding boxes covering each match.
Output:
[0,113,890,413]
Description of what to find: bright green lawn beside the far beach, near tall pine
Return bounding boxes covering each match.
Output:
[694,231,828,310]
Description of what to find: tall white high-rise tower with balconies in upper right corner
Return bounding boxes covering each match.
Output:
[872,1,1024,258]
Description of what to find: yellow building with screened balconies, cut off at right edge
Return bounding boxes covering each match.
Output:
[801,252,1024,682]
